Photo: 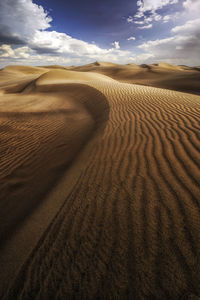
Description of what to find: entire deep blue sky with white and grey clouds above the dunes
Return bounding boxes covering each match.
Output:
[0,0,200,67]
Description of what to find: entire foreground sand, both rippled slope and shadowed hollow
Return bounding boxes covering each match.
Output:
[0,63,200,299]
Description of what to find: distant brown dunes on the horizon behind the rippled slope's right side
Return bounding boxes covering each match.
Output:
[72,63,200,95]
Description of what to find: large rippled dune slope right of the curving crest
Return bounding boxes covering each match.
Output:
[0,63,200,299]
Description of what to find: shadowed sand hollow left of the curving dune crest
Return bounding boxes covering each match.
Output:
[0,83,109,297]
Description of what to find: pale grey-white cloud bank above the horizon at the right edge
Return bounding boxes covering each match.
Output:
[139,18,200,65]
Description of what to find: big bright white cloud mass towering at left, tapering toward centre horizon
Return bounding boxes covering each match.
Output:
[0,0,137,66]
